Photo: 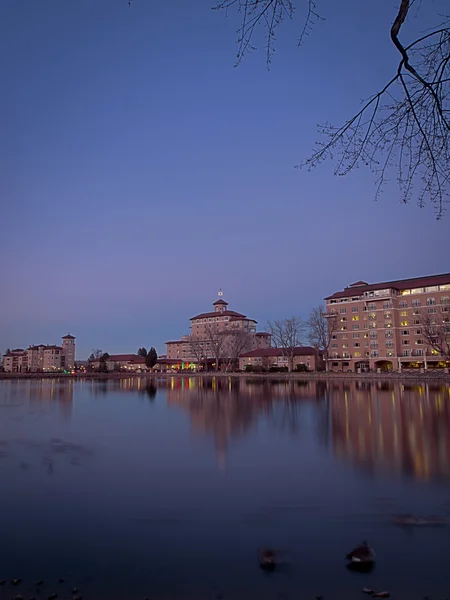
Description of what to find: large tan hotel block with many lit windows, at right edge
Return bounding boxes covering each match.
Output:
[325,274,450,371]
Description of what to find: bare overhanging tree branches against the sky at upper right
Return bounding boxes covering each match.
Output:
[214,0,450,219]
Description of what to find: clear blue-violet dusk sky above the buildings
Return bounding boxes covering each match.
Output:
[0,0,450,359]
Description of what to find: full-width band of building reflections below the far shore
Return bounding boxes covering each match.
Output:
[0,376,450,481]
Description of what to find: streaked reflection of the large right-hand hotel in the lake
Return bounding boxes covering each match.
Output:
[329,382,450,481]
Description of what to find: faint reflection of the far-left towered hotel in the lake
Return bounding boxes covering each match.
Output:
[2,378,75,419]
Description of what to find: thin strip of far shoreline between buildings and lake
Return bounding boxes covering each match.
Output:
[0,369,450,382]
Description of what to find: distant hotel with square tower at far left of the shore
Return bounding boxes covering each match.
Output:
[3,334,75,373]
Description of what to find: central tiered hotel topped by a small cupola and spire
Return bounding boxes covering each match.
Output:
[158,291,271,368]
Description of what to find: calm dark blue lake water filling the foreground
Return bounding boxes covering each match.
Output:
[0,378,450,600]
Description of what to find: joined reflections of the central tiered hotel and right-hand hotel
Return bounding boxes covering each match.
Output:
[161,377,450,480]
